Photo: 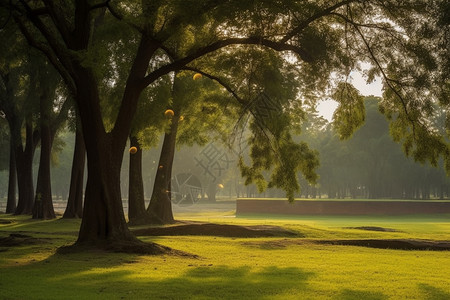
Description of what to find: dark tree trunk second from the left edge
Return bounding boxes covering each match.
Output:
[14,121,35,215]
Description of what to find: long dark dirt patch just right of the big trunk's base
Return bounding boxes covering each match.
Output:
[132,223,301,237]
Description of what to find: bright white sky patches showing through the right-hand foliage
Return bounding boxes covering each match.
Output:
[317,72,382,121]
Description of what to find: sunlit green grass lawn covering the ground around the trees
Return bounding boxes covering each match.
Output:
[0,212,450,300]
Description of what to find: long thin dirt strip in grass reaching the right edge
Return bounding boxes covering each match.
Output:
[242,239,450,251]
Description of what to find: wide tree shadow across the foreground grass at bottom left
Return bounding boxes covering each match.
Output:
[0,253,314,300]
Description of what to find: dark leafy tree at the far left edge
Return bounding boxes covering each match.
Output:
[0,34,39,214]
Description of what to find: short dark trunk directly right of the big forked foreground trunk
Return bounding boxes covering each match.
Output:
[128,135,147,225]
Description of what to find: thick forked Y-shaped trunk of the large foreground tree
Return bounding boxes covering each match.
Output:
[66,33,166,253]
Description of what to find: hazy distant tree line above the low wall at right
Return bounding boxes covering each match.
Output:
[302,97,450,199]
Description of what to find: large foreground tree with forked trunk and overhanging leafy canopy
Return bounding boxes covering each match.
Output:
[2,0,450,250]
